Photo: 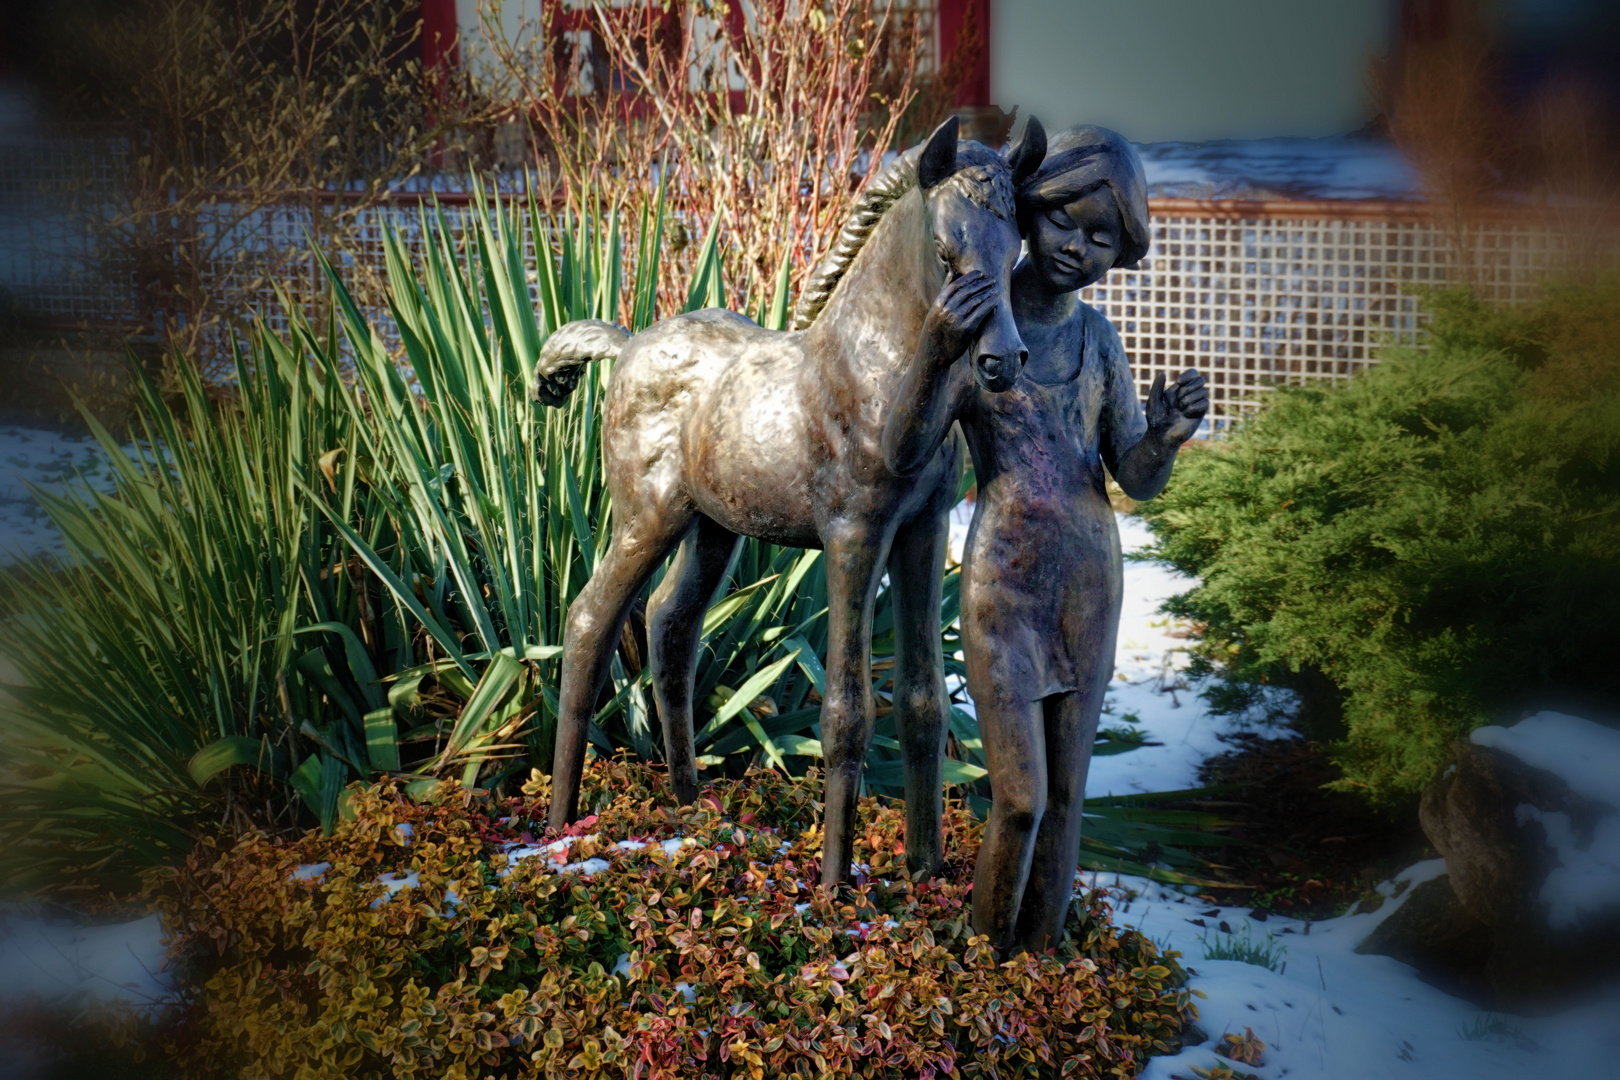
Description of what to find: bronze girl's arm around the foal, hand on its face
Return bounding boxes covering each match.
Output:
[883,270,996,476]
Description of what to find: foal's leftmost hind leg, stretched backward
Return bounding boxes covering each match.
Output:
[549,510,692,829]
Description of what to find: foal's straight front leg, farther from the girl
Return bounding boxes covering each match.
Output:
[821,521,888,886]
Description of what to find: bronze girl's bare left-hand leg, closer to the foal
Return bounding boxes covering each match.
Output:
[969,683,1048,952]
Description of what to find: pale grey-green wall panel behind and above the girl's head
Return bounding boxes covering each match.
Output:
[990,0,1393,142]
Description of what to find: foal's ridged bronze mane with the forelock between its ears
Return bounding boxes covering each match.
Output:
[791,142,1013,330]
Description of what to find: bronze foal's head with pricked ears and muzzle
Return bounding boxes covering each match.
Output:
[917,117,1047,393]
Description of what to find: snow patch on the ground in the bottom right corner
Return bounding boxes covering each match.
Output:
[1087,860,1620,1080]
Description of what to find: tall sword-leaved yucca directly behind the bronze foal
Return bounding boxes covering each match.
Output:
[302,186,983,792]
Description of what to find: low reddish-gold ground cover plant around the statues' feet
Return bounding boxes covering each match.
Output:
[152,759,1196,1078]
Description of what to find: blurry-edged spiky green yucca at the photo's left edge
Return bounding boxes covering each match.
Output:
[0,335,347,884]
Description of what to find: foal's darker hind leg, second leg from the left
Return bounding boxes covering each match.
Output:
[646,515,742,805]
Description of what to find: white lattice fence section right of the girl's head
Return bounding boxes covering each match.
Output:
[1081,199,1563,427]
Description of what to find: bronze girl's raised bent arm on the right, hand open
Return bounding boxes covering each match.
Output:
[1097,316,1209,502]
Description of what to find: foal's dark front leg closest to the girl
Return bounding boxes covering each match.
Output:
[889,499,949,878]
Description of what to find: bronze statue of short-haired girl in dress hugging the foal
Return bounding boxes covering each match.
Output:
[883,120,1209,952]
